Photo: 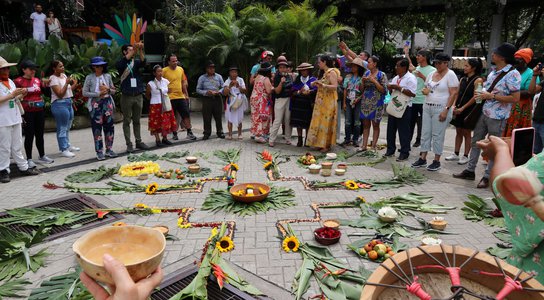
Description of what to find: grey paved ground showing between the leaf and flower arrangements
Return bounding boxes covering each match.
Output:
[0,113,498,299]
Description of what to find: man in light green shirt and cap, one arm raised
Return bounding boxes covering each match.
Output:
[404,47,436,147]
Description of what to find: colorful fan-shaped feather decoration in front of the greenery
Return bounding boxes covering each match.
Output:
[104,14,147,45]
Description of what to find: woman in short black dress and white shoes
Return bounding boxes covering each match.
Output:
[446,58,483,165]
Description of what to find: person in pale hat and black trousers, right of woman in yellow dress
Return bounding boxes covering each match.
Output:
[341,57,366,146]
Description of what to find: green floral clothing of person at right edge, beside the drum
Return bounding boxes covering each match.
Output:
[493,154,544,284]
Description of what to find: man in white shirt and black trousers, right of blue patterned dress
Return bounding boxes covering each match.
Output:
[386,58,417,161]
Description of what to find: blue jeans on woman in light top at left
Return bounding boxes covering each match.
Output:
[51,98,74,152]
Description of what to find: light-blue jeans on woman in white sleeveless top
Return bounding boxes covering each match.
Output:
[421,104,453,155]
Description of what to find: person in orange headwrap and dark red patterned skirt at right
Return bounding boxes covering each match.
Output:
[504,48,540,137]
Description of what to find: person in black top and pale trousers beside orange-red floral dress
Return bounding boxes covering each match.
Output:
[268,57,293,147]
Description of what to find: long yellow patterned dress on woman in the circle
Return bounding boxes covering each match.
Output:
[306,69,338,149]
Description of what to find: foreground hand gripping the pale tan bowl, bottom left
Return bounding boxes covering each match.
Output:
[79,254,163,300]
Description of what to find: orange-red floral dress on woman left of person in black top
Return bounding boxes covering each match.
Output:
[250,75,272,137]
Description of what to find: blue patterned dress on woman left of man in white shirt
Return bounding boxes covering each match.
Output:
[361,71,387,122]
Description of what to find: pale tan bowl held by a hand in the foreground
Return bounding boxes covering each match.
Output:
[72,225,166,284]
